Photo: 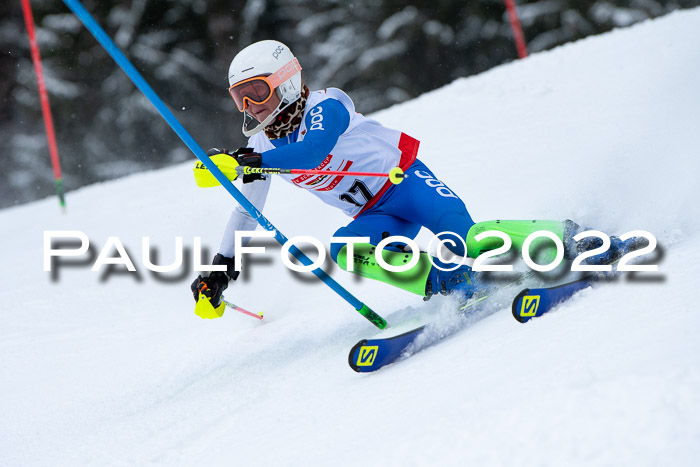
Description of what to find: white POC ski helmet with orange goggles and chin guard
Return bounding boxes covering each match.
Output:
[228,40,302,137]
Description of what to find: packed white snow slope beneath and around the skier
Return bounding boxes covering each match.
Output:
[0,9,700,466]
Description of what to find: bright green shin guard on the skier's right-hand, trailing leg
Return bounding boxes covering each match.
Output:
[467,220,564,258]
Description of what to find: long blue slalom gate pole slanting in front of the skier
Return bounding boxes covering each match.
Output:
[63,0,387,329]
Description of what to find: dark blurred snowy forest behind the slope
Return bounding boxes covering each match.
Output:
[0,0,700,207]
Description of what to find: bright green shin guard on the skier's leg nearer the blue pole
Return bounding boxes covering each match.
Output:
[337,243,432,297]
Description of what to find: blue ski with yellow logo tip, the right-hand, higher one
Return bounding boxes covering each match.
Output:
[511,276,592,323]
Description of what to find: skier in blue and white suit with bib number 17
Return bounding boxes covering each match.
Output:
[191,40,626,318]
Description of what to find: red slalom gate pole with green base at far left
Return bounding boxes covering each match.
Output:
[22,0,66,212]
